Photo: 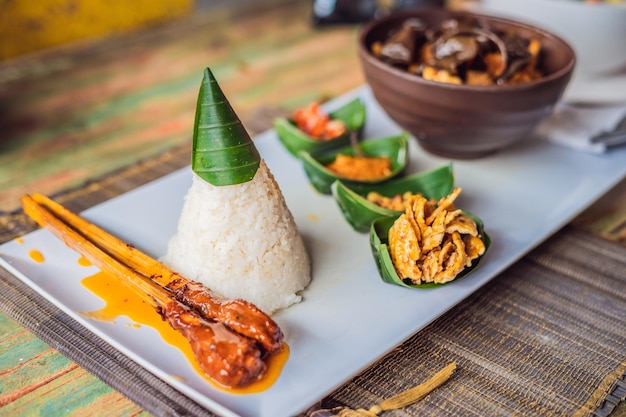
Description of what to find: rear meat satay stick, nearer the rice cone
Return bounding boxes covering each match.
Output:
[23,194,283,352]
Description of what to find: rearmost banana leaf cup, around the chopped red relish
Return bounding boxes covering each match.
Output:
[273,98,366,157]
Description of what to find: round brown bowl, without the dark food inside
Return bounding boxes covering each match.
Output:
[358,9,576,159]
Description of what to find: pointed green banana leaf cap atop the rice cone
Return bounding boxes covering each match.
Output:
[191,68,261,186]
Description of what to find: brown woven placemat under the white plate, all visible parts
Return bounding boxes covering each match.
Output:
[0,141,626,416]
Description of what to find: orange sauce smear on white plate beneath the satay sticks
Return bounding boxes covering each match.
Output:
[79,268,289,394]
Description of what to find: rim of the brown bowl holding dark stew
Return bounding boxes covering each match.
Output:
[358,7,577,93]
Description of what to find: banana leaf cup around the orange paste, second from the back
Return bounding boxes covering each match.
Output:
[299,133,409,194]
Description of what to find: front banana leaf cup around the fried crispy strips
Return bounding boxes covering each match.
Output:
[370,212,491,289]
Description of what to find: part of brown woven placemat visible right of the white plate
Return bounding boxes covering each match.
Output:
[312,227,626,416]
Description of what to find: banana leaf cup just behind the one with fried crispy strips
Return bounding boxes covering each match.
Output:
[331,164,454,233]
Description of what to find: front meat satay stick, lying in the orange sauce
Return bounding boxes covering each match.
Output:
[22,195,282,388]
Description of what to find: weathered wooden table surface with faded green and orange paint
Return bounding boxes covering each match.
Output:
[0,0,626,416]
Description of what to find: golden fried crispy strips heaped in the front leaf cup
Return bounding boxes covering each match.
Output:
[388,188,485,285]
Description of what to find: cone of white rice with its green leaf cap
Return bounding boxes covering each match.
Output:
[162,69,311,314]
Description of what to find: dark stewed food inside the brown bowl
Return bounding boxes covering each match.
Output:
[371,16,542,85]
